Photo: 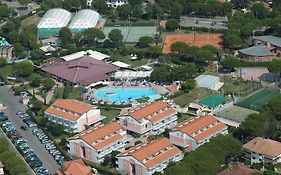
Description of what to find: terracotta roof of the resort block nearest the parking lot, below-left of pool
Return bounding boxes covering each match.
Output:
[45,99,92,121]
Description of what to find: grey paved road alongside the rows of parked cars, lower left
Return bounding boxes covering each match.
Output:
[0,87,59,174]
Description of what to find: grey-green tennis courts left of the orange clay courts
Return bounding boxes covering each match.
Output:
[103,26,157,43]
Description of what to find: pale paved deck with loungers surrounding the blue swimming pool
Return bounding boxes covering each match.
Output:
[83,82,169,106]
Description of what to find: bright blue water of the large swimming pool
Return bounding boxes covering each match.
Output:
[95,88,161,102]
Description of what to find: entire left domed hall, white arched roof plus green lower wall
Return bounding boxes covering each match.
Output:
[37,8,71,38]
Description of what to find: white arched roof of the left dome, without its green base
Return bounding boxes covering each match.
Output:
[37,8,71,29]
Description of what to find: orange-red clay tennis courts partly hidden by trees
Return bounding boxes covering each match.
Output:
[162,33,222,54]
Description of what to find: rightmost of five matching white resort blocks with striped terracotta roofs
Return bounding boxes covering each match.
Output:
[169,115,228,151]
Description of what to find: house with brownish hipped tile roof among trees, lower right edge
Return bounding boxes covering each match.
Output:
[243,137,281,164]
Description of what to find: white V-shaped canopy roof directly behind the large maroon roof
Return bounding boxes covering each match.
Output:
[61,50,110,61]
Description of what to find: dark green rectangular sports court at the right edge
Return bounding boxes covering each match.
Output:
[236,89,281,111]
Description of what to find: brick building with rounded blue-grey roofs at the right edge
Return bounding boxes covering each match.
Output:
[238,35,281,62]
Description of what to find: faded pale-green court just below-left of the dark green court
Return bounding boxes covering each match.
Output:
[216,105,258,123]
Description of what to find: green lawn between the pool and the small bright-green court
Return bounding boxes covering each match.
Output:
[173,88,212,106]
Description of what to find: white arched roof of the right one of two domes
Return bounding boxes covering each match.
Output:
[68,9,100,29]
